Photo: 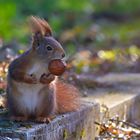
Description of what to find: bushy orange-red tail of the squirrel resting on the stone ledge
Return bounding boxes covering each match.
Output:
[56,81,80,113]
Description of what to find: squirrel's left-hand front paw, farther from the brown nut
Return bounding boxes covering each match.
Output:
[24,74,37,84]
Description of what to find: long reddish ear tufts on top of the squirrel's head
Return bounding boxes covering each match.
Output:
[30,16,52,37]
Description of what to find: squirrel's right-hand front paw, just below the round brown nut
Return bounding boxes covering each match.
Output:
[40,73,55,84]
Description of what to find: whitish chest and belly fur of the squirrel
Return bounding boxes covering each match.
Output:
[17,62,47,112]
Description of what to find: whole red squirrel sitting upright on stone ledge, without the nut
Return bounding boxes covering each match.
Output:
[7,16,79,122]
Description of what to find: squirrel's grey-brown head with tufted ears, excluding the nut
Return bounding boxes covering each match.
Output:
[30,16,65,61]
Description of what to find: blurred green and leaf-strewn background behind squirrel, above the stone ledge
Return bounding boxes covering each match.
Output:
[0,0,140,91]
